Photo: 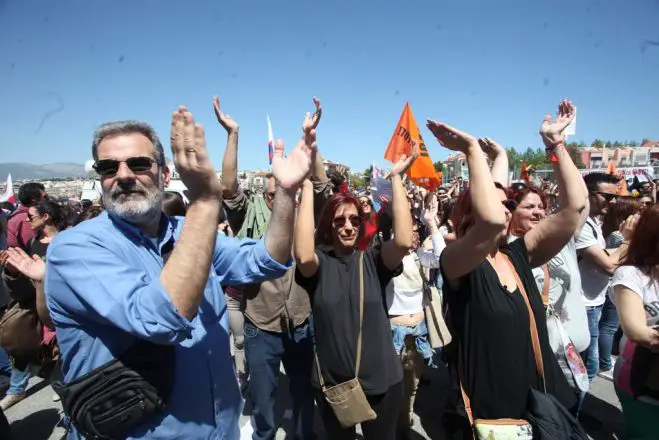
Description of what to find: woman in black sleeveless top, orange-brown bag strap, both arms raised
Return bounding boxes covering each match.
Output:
[428,101,585,419]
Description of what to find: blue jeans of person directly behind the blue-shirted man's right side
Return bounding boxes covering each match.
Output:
[245,317,316,440]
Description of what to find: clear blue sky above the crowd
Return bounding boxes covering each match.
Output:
[0,0,659,170]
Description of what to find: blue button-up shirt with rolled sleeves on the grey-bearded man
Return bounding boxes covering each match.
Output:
[45,212,288,440]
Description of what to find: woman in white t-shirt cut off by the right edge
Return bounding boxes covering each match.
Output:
[611,205,659,439]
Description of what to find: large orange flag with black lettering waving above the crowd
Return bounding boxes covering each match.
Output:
[384,102,442,191]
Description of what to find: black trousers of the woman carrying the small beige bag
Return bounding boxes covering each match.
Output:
[315,381,405,440]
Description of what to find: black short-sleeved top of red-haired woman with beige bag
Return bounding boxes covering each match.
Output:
[296,246,403,395]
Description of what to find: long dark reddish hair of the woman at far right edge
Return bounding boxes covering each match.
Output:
[620,205,659,282]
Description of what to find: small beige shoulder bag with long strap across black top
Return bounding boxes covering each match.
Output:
[314,252,377,428]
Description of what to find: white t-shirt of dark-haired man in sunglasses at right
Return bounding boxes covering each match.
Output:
[576,217,611,307]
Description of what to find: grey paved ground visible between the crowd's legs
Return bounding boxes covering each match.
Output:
[6,375,624,440]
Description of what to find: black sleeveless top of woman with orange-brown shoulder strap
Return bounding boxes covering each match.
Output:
[442,239,576,419]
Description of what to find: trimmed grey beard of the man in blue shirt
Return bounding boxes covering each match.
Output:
[102,179,165,224]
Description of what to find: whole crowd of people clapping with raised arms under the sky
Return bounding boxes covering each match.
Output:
[0,99,659,440]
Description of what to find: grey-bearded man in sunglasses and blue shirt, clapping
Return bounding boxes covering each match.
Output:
[45,107,316,440]
